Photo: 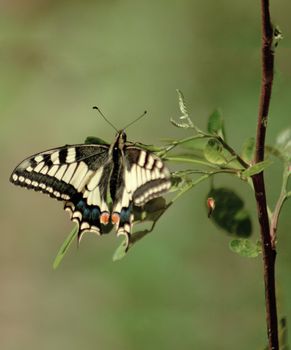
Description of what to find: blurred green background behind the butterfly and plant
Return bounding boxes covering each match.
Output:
[0,0,291,350]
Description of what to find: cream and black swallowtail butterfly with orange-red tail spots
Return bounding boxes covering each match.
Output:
[10,130,171,248]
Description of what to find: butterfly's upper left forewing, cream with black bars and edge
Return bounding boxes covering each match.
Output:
[10,145,108,200]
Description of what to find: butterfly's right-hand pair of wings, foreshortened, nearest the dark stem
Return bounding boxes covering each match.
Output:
[112,146,171,248]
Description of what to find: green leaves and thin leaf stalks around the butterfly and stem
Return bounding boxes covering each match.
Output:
[54,90,291,268]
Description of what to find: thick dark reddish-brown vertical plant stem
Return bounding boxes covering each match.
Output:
[252,0,279,350]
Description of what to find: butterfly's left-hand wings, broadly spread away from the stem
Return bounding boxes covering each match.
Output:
[10,144,112,239]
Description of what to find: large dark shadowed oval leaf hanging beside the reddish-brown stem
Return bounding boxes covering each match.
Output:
[207,187,252,238]
